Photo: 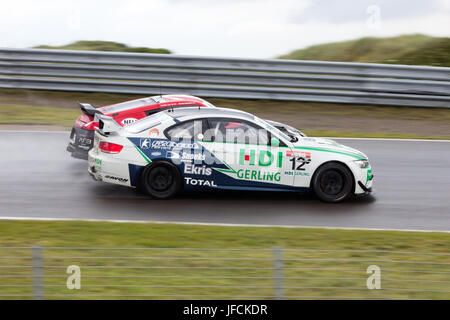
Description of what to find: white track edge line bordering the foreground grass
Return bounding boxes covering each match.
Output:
[0,217,450,233]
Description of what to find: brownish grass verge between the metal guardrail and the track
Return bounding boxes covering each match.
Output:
[0,89,450,139]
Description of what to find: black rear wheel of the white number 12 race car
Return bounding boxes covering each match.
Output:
[139,161,183,199]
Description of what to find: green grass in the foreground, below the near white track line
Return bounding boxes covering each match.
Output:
[0,221,450,299]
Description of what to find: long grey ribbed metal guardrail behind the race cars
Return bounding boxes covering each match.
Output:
[0,48,450,108]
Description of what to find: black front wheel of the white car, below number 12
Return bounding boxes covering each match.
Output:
[311,162,353,203]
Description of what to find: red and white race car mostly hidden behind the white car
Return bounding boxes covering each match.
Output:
[67,95,214,159]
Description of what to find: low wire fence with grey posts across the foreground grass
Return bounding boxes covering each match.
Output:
[0,247,450,299]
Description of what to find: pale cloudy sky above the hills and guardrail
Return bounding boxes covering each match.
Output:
[0,0,450,58]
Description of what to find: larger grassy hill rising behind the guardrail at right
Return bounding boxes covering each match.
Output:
[280,34,450,67]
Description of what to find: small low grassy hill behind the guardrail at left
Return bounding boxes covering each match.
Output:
[34,40,171,53]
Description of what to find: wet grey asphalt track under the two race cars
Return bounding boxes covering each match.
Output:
[0,131,450,231]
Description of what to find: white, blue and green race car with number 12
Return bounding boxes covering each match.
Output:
[88,108,373,202]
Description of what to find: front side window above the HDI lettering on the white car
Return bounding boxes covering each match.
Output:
[205,118,270,145]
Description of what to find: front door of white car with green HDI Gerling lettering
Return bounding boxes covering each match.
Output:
[205,118,294,189]
